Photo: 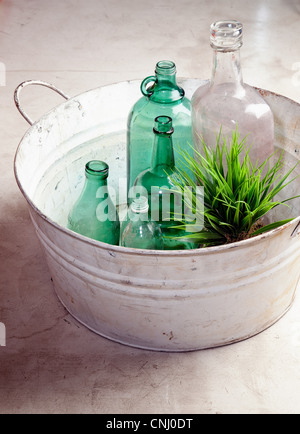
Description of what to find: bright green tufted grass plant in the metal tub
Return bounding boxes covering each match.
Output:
[173,130,299,246]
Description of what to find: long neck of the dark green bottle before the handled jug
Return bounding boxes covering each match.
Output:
[151,116,175,176]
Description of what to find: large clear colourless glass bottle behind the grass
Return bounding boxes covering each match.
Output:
[191,20,274,164]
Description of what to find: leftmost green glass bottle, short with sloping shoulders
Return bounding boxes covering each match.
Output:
[68,160,120,245]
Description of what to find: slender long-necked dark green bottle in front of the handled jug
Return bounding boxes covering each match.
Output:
[131,116,197,250]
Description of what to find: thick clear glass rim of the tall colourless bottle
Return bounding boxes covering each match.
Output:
[210,20,243,51]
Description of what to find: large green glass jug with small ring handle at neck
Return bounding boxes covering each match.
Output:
[127,60,192,191]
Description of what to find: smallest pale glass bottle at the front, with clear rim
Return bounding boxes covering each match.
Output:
[120,196,163,250]
